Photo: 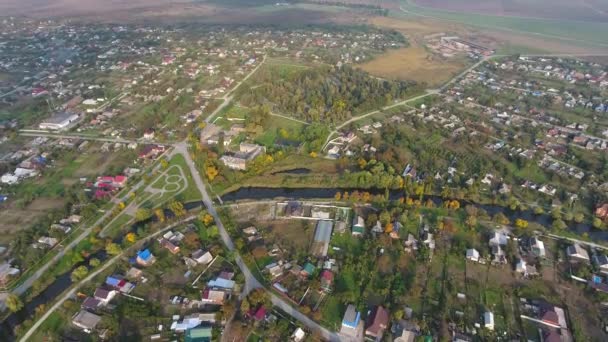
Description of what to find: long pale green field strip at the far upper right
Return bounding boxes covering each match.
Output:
[391,0,608,47]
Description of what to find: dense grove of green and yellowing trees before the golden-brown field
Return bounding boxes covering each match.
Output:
[241,66,415,124]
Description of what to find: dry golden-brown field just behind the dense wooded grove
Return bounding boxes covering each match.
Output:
[361,46,465,87]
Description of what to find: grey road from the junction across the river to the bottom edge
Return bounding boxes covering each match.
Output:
[175,143,340,341]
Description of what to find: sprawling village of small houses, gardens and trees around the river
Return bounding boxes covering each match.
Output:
[0,12,608,342]
